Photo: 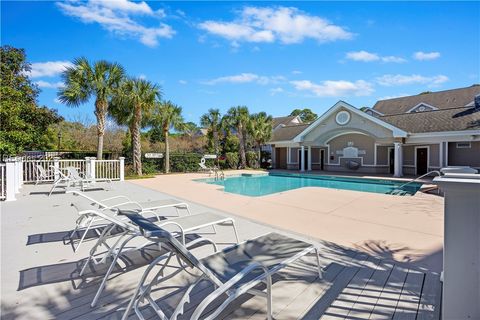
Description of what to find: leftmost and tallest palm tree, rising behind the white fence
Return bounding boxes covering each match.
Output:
[58,57,125,159]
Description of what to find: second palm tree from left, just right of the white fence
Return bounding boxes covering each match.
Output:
[111,79,161,176]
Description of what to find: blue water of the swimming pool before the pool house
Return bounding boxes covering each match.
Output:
[197,173,422,197]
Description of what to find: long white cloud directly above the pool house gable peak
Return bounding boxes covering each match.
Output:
[290,80,374,97]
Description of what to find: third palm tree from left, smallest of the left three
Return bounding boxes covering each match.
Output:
[154,101,184,173]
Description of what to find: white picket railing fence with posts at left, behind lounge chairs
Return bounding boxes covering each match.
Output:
[0,157,125,201]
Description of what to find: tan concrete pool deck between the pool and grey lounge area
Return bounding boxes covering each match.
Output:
[130,170,443,271]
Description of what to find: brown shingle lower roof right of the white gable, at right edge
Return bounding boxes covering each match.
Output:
[378,107,480,133]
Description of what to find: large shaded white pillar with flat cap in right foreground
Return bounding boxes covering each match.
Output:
[433,174,480,319]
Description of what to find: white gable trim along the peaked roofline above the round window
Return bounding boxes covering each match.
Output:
[292,100,408,142]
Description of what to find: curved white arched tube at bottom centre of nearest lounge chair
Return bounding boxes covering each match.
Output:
[191,262,271,319]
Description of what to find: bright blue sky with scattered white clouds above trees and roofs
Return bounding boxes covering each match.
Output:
[1,0,480,122]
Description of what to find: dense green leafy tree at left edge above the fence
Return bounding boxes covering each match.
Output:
[0,46,62,155]
